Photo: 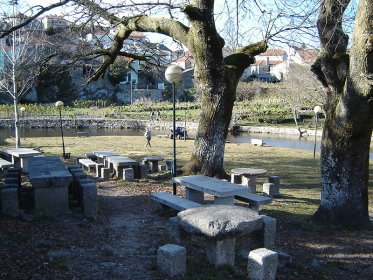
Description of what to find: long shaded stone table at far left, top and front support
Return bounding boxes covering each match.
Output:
[28,156,72,215]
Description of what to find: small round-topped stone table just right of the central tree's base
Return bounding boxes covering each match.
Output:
[231,168,267,193]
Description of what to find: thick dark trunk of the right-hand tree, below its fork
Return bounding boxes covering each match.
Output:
[315,98,372,228]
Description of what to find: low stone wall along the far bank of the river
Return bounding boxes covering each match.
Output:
[0,117,322,136]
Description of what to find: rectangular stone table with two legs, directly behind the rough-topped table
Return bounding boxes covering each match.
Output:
[173,175,248,205]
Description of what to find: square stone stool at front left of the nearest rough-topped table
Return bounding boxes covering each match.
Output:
[157,244,186,278]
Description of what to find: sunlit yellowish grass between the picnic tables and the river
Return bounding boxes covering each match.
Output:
[3,136,373,220]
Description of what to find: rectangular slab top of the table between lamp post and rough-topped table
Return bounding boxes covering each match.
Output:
[173,175,247,197]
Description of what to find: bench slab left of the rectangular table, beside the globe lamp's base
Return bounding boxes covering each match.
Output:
[150,192,201,211]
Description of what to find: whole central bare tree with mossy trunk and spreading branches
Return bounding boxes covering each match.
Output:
[0,0,315,177]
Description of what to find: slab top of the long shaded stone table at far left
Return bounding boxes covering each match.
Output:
[29,156,72,187]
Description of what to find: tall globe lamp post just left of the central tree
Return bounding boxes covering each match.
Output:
[165,65,183,194]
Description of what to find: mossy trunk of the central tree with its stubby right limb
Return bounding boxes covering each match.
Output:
[182,0,267,178]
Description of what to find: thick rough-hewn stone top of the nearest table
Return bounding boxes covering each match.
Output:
[177,205,263,240]
